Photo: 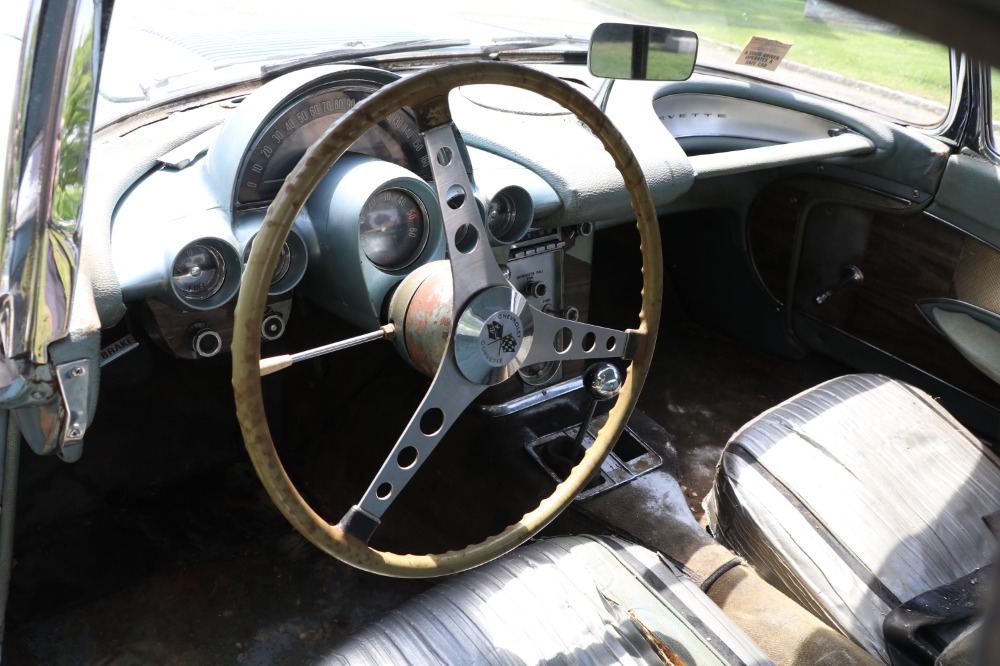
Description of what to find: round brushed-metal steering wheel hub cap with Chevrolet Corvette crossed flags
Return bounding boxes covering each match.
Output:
[455,287,534,386]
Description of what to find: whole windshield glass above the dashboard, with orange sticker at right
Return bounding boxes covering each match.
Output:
[98,0,950,126]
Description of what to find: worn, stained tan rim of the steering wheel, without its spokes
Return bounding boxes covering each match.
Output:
[233,63,663,577]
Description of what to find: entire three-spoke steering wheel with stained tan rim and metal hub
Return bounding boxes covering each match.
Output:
[232,63,663,577]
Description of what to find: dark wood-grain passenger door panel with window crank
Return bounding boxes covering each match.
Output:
[748,178,1000,408]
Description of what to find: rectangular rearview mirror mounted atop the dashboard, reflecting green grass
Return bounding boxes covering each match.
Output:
[587,23,698,81]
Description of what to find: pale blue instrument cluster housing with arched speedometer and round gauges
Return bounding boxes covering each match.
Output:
[112,66,559,358]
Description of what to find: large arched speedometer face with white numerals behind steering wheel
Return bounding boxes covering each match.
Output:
[234,82,431,209]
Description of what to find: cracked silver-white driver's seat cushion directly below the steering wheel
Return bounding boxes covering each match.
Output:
[324,537,771,665]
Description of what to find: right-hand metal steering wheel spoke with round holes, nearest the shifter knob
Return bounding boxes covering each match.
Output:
[524,306,638,365]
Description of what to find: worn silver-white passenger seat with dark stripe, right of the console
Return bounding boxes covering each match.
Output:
[705,375,1000,661]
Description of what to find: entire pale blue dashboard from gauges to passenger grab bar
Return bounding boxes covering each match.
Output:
[101,59,930,391]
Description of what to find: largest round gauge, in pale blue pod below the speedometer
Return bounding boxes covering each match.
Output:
[360,188,427,271]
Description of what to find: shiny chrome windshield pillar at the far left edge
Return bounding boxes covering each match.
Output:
[0,0,100,374]
